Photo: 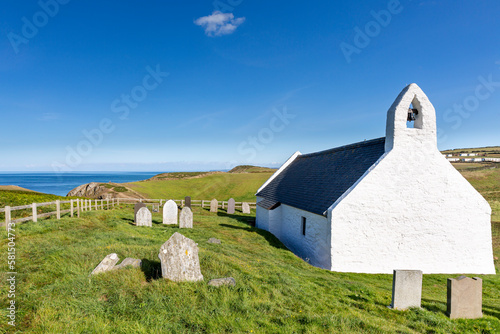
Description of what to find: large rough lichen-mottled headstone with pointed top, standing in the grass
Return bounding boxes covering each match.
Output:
[158,232,203,282]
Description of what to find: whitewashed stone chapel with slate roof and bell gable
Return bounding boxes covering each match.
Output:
[256,84,495,274]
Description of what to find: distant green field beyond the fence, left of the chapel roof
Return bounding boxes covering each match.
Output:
[124,171,273,202]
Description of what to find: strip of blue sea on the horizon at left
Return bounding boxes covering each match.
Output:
[0,172,160,196]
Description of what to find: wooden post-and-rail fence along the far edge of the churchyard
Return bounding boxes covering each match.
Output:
[0,198,256,230]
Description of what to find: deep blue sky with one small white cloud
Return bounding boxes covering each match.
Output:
[0,0,500,171]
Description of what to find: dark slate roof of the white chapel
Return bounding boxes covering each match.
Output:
[256,138,385,215]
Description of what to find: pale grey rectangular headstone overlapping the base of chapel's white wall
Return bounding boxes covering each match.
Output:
[390,270,422,310]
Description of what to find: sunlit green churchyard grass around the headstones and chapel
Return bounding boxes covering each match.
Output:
[0,206,500,334]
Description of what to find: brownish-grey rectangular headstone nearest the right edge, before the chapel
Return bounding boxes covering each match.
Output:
[446,276,483,319]
